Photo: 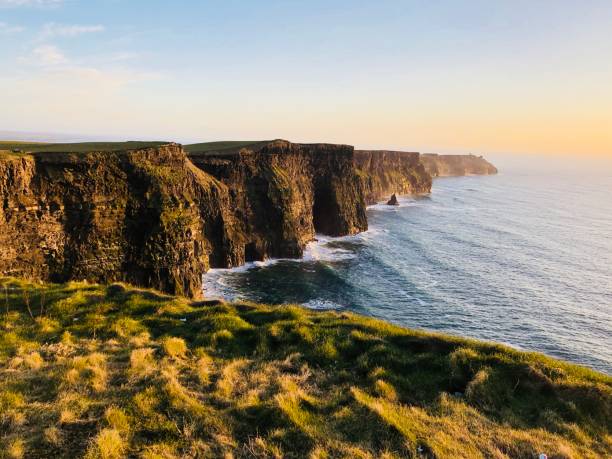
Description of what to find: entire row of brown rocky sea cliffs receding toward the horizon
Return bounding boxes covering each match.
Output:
[0,140,496,297]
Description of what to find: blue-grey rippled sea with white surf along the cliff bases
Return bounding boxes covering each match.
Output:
[205,156,612,374]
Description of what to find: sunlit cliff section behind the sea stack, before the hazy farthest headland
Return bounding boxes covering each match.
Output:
[355,150,431,204]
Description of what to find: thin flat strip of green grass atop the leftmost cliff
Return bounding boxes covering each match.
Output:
[0,141,168,154]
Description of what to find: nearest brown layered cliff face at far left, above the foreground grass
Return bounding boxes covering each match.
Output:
[0,144,242,296]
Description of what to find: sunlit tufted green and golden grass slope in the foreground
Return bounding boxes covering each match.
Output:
[0,279,612,458]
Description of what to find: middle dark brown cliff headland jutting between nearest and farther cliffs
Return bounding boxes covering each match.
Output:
[187,140,367,261]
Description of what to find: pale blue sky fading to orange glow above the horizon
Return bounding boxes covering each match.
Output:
[0,0,612,156]
